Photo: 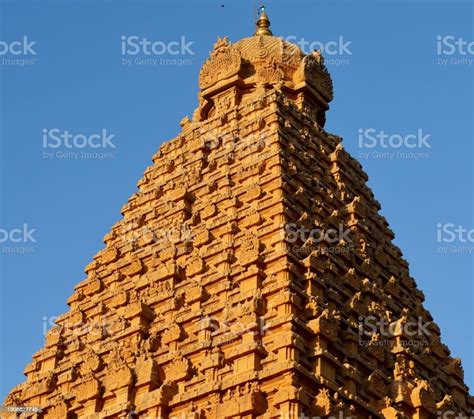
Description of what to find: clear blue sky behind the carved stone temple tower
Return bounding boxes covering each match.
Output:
[0,0,474,398]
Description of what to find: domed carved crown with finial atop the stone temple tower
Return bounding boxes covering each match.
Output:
[197,9,333,124]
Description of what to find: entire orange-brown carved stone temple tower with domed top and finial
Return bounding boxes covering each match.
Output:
[5,7,474,419]
